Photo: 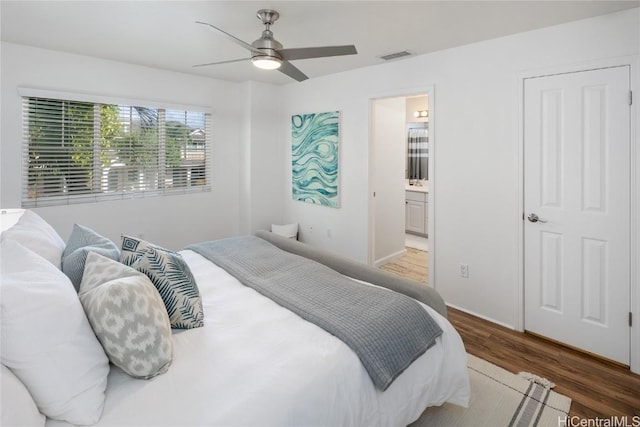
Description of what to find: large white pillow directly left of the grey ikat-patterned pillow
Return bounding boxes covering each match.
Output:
[0,239,109,425]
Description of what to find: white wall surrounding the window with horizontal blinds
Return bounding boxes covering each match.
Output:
[0,43,245,249]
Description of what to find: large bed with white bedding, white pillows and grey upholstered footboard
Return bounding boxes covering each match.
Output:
[1,211,469,427]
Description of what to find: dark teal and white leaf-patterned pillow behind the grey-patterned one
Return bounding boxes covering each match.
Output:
[120,236,204,329]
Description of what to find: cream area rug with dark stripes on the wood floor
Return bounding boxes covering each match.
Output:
[411,355,571,427]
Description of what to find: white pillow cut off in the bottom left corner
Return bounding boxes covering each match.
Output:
[0,365,46,427]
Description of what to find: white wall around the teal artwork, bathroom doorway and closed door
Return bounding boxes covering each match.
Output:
[283,9,640,326]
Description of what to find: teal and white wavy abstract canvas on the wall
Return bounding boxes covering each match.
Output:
[291,111,340,208]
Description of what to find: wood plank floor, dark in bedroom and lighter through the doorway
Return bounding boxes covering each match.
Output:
[381,250,640,420]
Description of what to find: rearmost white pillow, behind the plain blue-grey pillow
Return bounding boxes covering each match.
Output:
[2,210,65,269]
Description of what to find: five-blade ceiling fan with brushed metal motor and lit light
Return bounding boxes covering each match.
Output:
[194,9,358,82]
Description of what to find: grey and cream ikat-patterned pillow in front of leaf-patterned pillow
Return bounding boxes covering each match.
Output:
[78,252,173,379]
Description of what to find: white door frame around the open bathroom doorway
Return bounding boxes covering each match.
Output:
[367,85,437,289]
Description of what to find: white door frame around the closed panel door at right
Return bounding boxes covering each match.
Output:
[514,55,640,373]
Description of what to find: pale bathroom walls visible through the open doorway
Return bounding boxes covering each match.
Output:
[369,88,435,286]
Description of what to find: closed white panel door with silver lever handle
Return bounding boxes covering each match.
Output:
[524,66,631,365]
